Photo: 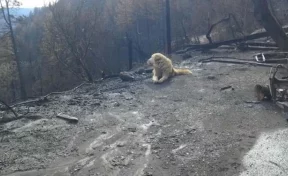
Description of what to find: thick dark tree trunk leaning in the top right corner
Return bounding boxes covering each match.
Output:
[252,0,288,50]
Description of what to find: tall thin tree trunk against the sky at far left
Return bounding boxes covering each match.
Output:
[0,0,27,99]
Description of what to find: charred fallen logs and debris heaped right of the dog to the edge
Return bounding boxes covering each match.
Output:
[176,23,288,118]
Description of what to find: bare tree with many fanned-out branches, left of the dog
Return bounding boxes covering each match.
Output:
[49,0,99,82]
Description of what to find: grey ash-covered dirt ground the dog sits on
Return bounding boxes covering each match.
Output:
[0,51,288,176]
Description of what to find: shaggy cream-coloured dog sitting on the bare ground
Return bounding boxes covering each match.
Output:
[147,53,192,83]
